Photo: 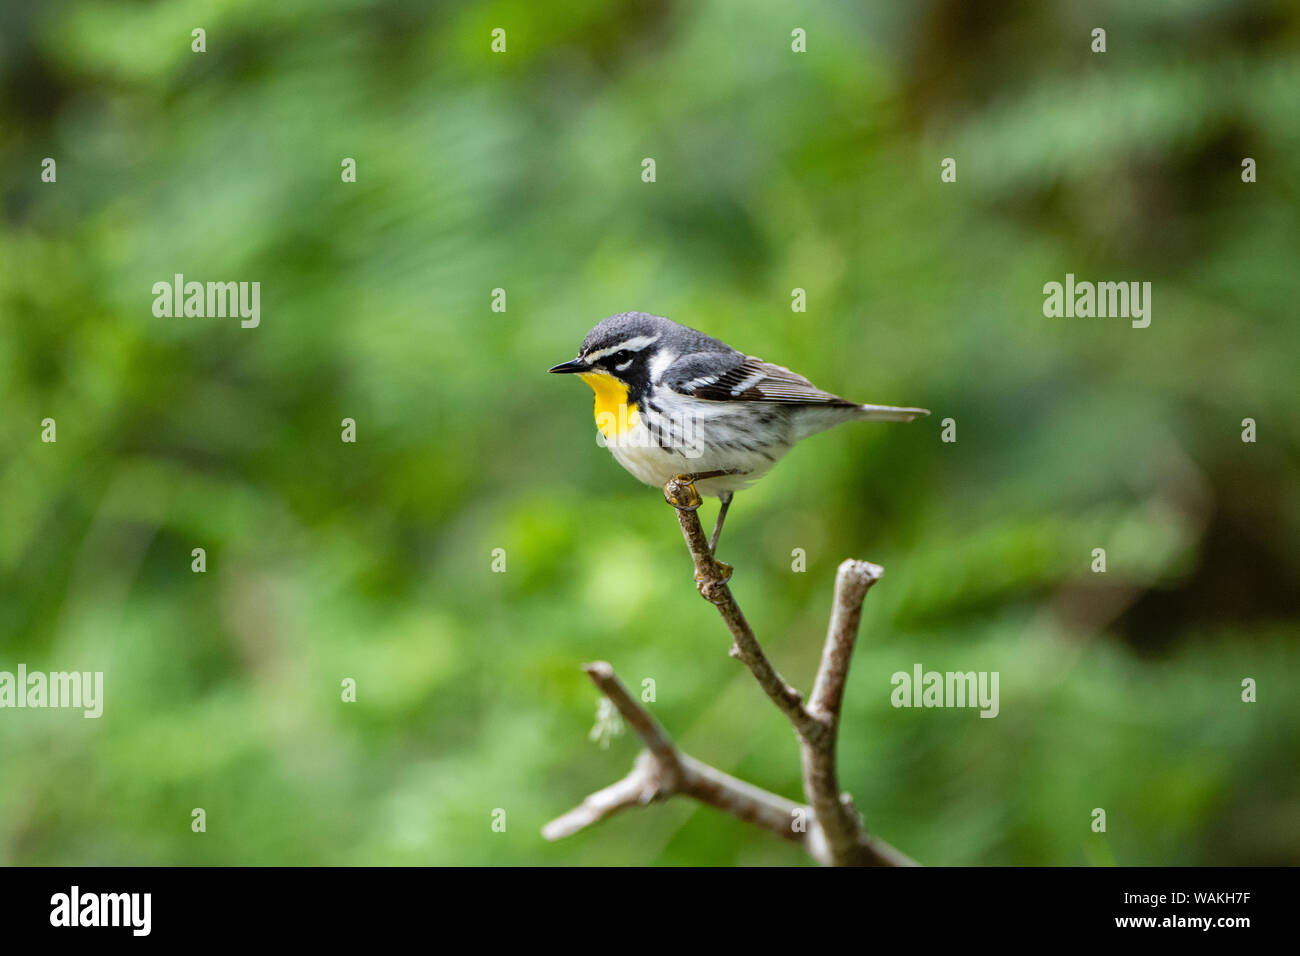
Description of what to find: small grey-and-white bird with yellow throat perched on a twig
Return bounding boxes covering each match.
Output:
[550,312,930,554]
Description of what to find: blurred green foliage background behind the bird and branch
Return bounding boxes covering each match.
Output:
[0,0,1300,865]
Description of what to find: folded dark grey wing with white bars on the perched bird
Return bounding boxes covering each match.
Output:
[662,351,857,406]
